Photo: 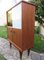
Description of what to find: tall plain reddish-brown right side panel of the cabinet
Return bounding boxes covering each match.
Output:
[22,3,35,50]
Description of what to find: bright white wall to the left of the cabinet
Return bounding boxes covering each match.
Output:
[0,0,16,26]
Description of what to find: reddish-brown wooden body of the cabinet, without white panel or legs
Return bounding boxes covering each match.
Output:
[7,1,35,52]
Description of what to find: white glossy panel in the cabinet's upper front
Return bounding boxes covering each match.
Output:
[12,4,22,29]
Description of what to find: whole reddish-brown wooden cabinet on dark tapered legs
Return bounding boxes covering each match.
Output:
[7,1,35,57]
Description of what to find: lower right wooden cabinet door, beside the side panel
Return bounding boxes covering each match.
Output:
[12,29,22,48]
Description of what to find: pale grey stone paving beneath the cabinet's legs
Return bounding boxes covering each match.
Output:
[0,38,44,60]
